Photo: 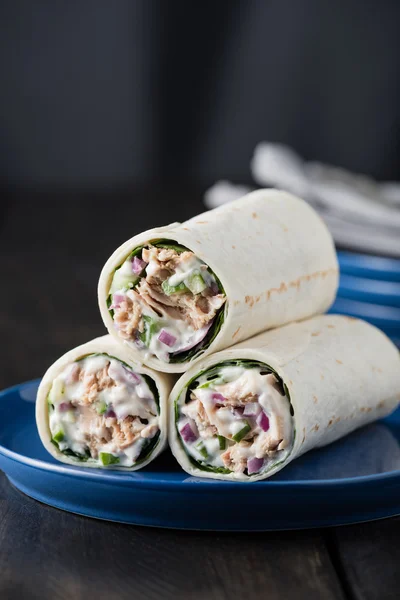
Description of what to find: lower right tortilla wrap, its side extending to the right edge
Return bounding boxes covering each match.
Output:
[169,315,400,481]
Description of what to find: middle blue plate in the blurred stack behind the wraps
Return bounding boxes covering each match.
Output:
[338,273,400,308]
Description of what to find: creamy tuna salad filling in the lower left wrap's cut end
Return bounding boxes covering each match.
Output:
[48,354,160,467]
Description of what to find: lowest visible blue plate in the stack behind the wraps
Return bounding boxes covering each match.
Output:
[329,300,400,336]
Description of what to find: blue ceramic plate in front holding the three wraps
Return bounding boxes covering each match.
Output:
[0,381,400,531]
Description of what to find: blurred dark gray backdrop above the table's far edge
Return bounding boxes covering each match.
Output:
[0,0,400,188]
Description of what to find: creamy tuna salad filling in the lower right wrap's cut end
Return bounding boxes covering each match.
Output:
[175,360,295,477]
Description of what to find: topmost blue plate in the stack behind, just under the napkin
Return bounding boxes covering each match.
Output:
[338,252,400,281]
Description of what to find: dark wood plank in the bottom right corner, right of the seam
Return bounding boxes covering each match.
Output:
[330,517,400,600]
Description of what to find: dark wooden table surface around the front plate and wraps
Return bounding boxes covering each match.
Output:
[0,186,400,600]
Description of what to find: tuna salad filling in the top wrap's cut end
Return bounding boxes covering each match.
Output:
[107,241,226,362]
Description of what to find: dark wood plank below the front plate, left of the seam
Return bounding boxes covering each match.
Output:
[0,475,344,600]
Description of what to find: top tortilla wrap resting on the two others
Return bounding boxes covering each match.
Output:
[98,190,338,373]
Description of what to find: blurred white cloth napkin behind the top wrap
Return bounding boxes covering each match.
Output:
[204,142,400,257]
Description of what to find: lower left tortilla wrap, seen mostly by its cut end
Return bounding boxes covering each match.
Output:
[36,335,174,471]
